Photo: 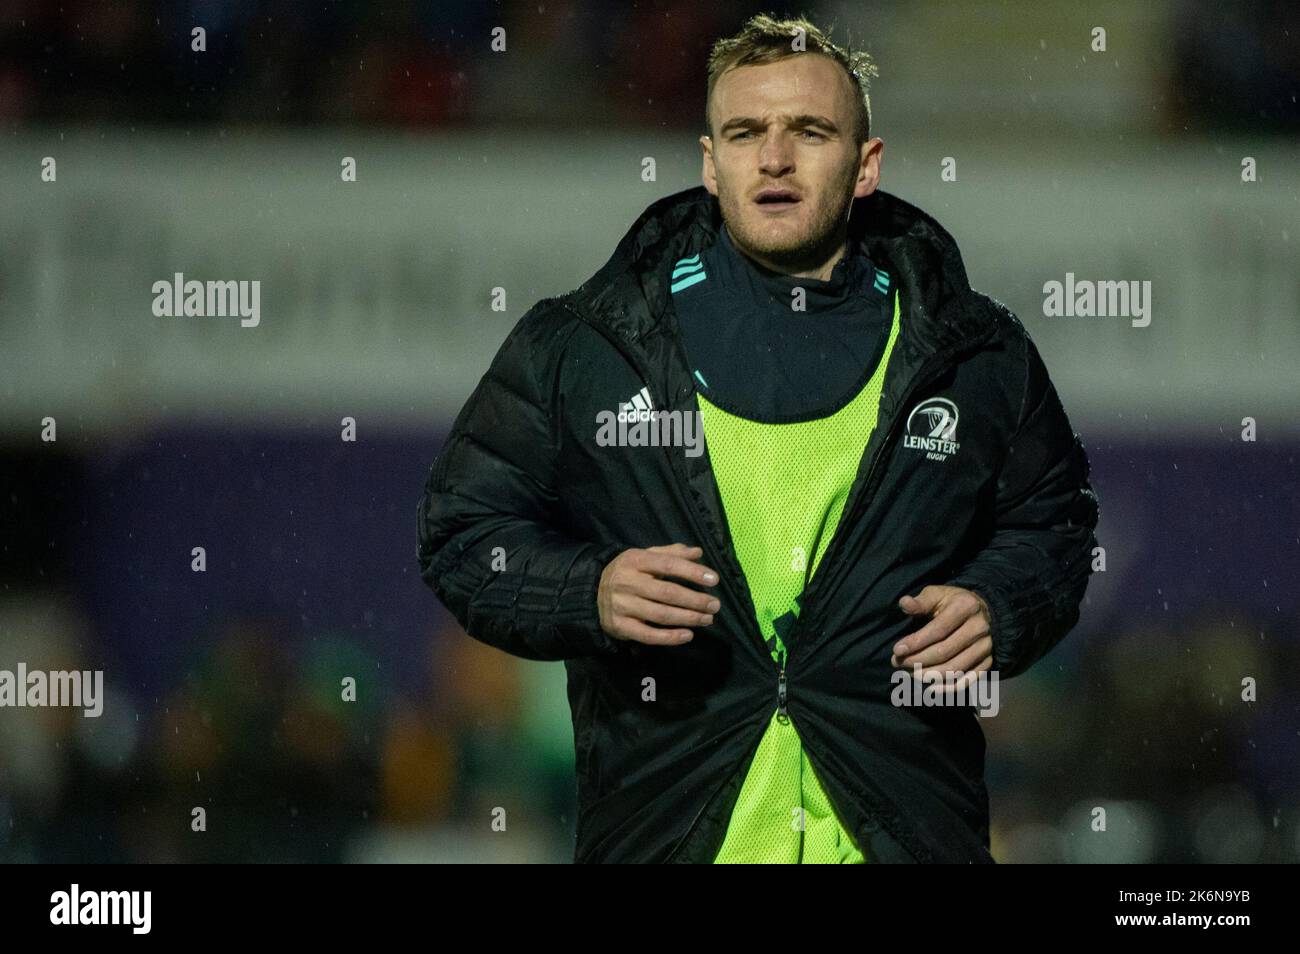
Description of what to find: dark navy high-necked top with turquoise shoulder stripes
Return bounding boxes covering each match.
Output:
[670,225,893,422]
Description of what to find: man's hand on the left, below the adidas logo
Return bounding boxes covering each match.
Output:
[595,543,722,646]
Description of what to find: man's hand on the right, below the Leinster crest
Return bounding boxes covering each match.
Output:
[889,585,993,686]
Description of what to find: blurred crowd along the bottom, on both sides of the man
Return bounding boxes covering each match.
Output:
[0,582,1300,863]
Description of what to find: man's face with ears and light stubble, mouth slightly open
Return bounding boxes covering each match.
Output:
[699,53,884,270]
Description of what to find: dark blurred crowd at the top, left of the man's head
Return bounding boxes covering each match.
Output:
[0,0,744,126]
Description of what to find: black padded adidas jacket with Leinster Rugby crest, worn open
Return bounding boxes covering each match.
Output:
[417,187,1099,862]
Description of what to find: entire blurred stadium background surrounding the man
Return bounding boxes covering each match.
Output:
[0,0,1300,862]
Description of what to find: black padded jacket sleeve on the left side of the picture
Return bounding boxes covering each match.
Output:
[416,302,624,659]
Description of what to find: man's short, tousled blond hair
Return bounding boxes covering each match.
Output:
[705,13,880,146]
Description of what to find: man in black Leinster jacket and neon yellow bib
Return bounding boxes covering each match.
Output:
[419,17,1099,862]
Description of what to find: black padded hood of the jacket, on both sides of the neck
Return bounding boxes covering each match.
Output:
[569,186,993,355]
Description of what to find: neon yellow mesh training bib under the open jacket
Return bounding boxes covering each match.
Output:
[696,285,900,864]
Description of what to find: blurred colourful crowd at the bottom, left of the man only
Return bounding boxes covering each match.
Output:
[0,591,585,862]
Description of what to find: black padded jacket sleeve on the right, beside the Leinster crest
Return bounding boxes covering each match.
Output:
[949,320,1100,678]
